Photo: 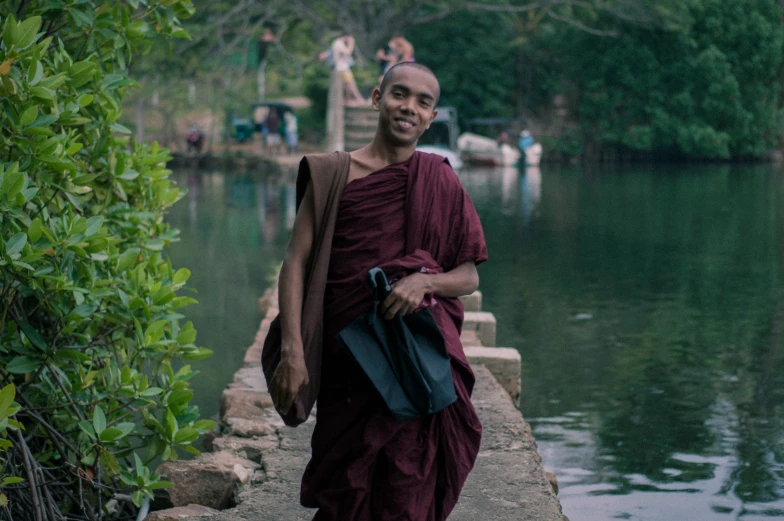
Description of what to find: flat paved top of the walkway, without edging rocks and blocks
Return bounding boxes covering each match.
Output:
[201,365,565,521]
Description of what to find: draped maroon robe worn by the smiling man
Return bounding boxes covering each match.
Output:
[301,148,487,521]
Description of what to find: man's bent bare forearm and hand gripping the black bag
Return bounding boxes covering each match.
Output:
[381,261,479,319]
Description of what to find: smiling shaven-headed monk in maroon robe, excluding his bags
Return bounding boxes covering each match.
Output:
[272,62,487,521]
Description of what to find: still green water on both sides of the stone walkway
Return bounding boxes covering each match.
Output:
[169,165,784,521]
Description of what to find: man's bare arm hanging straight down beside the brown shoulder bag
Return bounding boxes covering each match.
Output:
[270,184,315,414]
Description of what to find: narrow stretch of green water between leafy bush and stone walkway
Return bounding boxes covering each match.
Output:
[167,170,295,422]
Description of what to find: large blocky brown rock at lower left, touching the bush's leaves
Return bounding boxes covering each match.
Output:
[158,452,261,510]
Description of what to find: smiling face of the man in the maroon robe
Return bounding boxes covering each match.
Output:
[372,66,440,147]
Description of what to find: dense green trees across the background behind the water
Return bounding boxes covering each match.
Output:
[132,0,784,159]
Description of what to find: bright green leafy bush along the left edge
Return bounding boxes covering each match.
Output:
[0,0,214,519]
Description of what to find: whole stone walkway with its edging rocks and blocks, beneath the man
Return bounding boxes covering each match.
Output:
[147,280,568,521]
